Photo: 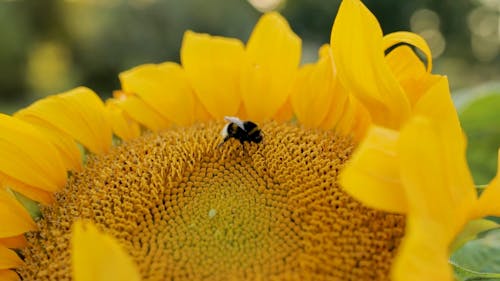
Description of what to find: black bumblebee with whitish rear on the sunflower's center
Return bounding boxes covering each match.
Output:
[219,116,262,146]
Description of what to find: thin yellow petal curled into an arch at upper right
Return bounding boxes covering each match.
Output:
[382,31,432,73]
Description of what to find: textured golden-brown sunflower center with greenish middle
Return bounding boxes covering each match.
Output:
[19,123,404,280]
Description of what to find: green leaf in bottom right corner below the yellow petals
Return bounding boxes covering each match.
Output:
[450,228,500,281]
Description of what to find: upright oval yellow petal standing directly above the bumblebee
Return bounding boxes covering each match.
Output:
[240,13,301,122]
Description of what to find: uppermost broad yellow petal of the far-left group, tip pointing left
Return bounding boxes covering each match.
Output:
[16,87,112,154]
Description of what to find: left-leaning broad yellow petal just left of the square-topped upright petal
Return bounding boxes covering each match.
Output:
[120,62,195,126]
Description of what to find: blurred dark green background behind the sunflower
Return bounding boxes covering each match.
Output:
[0,0,500,184]
